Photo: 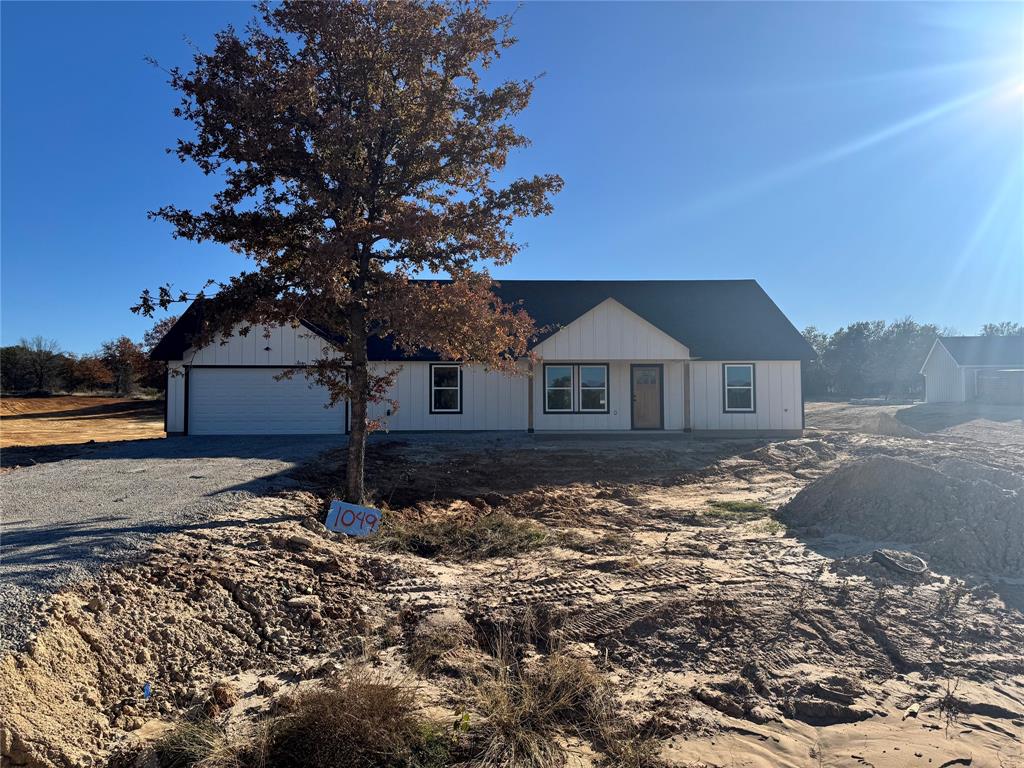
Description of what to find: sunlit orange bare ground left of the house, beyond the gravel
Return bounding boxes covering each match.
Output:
[0,395,164,466]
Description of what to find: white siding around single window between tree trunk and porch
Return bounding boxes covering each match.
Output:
[370,362,529,431]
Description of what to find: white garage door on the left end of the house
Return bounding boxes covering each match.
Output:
[188,368,345,434]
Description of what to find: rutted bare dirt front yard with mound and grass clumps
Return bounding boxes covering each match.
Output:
[0,403,1024,768]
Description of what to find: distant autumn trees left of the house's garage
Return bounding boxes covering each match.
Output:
[0,316,177,396]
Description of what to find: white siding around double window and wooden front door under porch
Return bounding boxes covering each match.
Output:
[532,360,683,432]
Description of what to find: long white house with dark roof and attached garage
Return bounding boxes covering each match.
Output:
[153,281,814,434]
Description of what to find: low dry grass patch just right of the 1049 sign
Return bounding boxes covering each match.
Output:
[371,512,553,560]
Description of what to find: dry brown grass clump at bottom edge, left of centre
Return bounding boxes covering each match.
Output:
[154,674,458,768]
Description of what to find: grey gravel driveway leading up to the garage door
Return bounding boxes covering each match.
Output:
[0,435,344,650]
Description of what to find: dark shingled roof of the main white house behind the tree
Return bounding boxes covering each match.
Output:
[153,280,814,360]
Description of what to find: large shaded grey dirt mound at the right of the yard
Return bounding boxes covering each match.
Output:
[779,456,1024,574]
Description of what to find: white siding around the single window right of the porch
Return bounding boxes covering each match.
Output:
[690,360,804,430]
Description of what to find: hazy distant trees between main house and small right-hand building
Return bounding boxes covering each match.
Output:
[804,317,1024,398]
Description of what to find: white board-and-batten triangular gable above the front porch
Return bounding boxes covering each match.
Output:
[534,299,690,362]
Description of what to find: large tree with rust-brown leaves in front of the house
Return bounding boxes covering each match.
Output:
[135,0,562,502]
